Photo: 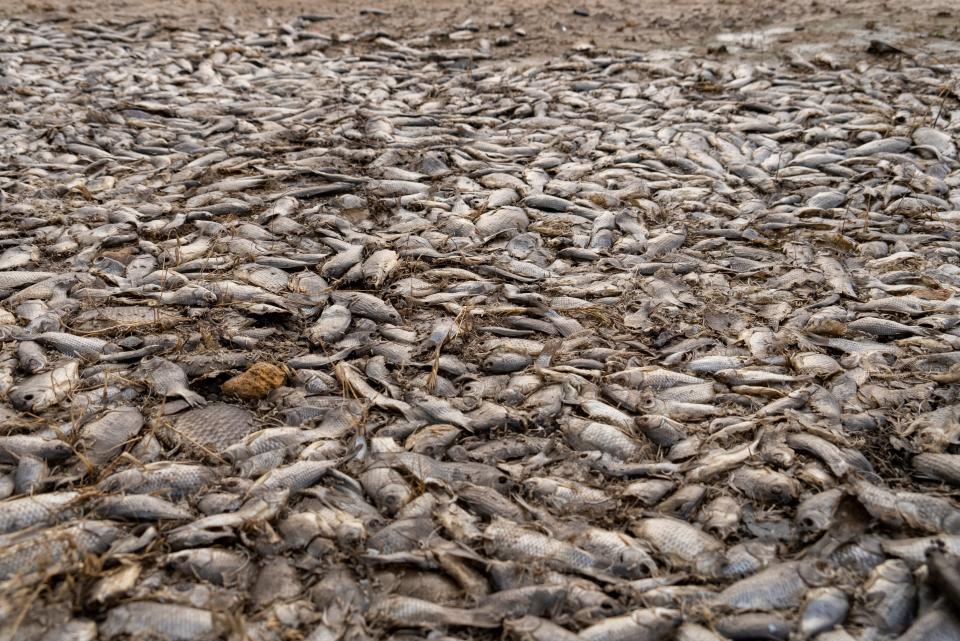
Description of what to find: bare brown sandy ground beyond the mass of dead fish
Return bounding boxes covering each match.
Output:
[0,0,960,59]
